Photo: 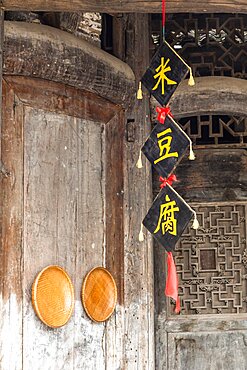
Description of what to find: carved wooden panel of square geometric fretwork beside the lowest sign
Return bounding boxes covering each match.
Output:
[170,203,247,315]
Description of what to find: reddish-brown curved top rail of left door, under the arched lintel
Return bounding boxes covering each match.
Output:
[5,76,121,123]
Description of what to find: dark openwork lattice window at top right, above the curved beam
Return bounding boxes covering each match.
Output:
[151,14,247,78]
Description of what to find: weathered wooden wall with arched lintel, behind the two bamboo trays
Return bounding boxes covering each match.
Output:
[0,21,154,370]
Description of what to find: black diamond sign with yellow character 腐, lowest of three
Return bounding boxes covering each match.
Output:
[143,184,194,252]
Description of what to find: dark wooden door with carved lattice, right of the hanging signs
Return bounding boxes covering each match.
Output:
[154,95,247,370]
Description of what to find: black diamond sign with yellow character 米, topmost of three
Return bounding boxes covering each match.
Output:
[141,42,189,106]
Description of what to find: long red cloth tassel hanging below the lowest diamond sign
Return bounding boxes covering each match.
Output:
[165,252,180,313]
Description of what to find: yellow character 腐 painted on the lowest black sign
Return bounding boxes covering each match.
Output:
[154,195,179,235]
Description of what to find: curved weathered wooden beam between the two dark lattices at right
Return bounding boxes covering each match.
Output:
[169,76,247,118]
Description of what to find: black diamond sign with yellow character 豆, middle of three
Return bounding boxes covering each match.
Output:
[142,116,190,178]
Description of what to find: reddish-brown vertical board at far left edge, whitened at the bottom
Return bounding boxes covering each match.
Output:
[0,81,23,370]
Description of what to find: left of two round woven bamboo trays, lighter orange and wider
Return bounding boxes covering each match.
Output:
[32,266,74,328]
